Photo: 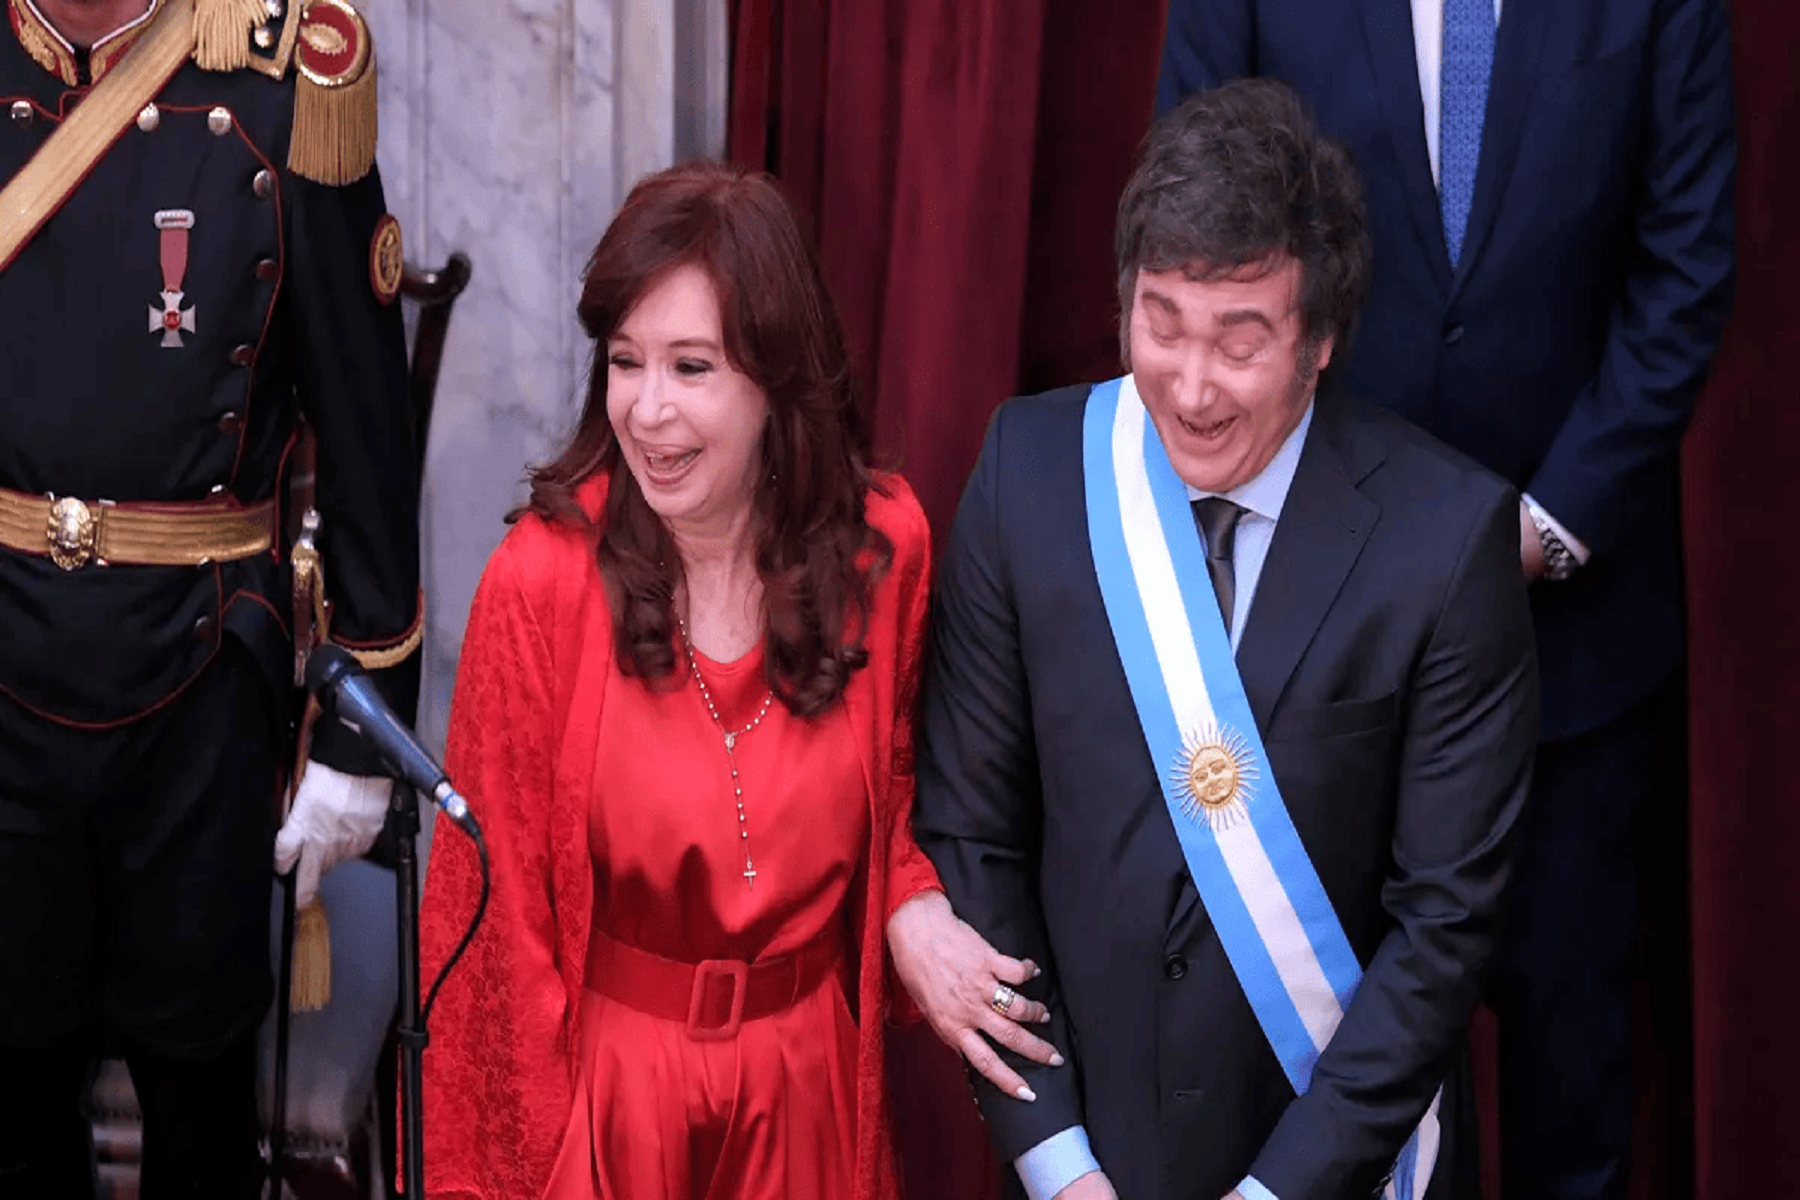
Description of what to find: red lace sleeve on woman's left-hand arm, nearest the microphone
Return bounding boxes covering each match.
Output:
[421,518,571,1200]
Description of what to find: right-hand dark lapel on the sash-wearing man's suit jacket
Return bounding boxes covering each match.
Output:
[1237,396,1381,734]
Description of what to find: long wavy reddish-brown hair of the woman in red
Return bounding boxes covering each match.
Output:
[527,162,893,716]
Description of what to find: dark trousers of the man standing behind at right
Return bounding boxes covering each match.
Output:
[1490,684,1683,1200]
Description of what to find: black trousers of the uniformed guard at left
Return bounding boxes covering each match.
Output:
[0,640,281,1200]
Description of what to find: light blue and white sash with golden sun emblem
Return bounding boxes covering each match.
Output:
[1082,376,1442,1200]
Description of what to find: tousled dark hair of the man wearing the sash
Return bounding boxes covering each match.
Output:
[1114,79,1370,369]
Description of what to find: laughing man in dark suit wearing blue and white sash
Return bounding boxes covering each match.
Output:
[914,83,1537,1200]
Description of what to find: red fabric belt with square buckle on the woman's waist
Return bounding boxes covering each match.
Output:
[587,927,842,1042]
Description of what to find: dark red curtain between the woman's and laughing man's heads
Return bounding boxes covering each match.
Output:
[731,0,1166,534]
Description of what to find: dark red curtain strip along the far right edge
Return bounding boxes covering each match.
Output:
[1683,0,1800,1200]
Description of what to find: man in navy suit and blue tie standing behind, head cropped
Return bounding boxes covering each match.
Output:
[1157,0,1735,1200]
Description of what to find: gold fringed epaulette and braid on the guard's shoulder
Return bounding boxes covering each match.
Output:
[194,0,376,187]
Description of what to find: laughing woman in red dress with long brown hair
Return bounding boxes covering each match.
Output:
[423,164,1048,1200]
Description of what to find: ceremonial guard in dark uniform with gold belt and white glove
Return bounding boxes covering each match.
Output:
[0,0,423,1200]
